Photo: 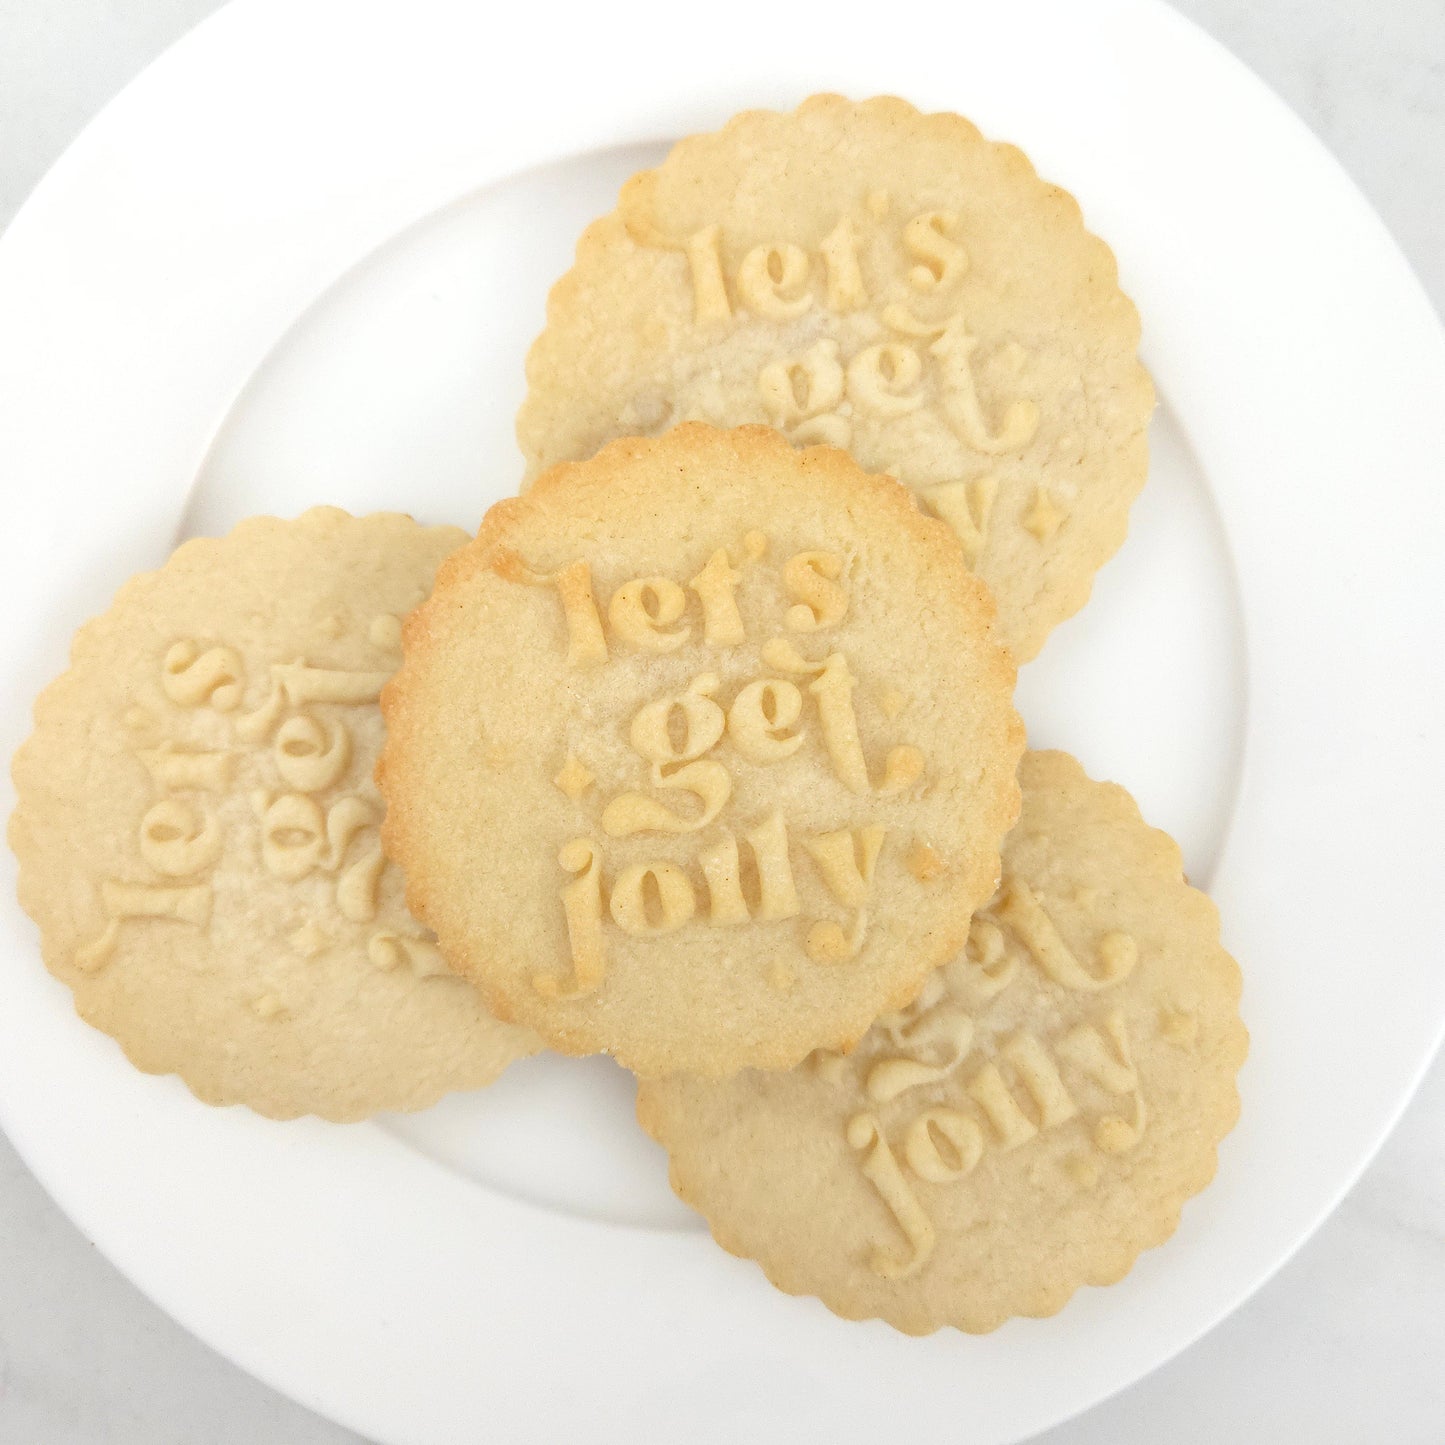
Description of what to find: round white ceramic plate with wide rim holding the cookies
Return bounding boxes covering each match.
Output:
[0,0,1445,1445]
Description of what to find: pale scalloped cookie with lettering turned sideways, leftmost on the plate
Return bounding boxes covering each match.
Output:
[10,507,539,1120]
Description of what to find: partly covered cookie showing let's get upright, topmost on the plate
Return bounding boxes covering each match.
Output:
[517,95,1153,660]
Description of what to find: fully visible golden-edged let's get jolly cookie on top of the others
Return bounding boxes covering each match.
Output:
[379,425,1023,1075]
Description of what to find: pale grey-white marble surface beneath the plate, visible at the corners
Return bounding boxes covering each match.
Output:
[0,0,1445,1445]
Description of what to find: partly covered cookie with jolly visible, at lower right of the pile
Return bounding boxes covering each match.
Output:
[637,753,1248,1334]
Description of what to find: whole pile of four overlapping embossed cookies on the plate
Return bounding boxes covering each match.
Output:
[10,95,1247,1332]
